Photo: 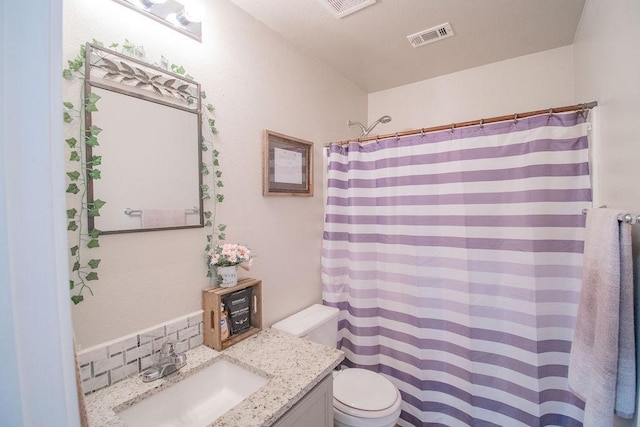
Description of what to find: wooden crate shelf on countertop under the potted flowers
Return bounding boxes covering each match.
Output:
[202,278,262,351]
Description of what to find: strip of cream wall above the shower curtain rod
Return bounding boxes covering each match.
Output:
[369,46,576,134]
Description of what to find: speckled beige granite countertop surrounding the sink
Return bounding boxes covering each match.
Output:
[85,329,344,427]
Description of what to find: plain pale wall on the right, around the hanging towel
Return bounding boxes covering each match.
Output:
[574,0,640,426]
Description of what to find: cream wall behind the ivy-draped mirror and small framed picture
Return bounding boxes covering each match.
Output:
[64,0,367,348]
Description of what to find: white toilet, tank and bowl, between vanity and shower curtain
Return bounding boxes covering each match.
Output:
[271,304,402,427]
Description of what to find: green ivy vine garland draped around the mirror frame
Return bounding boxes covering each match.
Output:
[62,40,226,304]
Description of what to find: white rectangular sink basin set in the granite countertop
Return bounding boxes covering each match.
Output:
[118,359,269,427]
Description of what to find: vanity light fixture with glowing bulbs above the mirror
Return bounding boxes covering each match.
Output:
[113,0,203,42]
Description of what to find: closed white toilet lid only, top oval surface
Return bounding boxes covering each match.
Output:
[333,368,398,411]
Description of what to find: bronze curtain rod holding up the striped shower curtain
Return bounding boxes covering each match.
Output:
[324,101,598,147]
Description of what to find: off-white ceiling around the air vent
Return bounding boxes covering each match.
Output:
[226,0,584,93]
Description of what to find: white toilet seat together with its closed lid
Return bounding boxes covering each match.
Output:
[333,368,401,418]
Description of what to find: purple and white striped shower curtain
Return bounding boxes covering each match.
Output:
[322,113,591,427]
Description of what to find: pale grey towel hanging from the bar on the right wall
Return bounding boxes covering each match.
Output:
[568,209,635,427]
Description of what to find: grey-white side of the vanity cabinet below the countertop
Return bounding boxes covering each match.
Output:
[273,374,333,427]
